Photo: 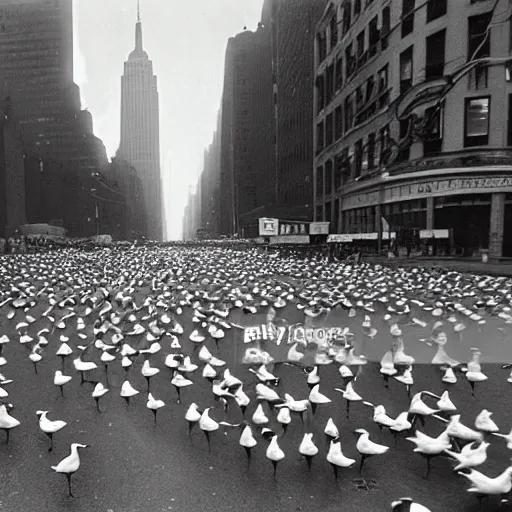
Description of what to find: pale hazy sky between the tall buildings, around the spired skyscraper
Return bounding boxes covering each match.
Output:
[73,0,263,239]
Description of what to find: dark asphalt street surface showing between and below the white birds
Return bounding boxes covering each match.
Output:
[0,280,512,512]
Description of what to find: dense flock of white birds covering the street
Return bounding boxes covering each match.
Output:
[0,249,512,512]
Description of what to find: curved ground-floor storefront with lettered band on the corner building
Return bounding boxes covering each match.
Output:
[340,172,512,258]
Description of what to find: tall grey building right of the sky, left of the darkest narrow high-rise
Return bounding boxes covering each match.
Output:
[219,7,276,236]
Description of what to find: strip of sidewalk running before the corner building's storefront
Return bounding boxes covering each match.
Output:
[364,256,512,277]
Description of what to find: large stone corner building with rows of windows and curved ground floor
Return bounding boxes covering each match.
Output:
[313,0,512,258]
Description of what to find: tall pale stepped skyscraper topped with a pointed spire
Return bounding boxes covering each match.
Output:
[117,4,163,241]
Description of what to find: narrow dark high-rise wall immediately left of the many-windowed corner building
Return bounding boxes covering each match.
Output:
[273,0,327,221]
